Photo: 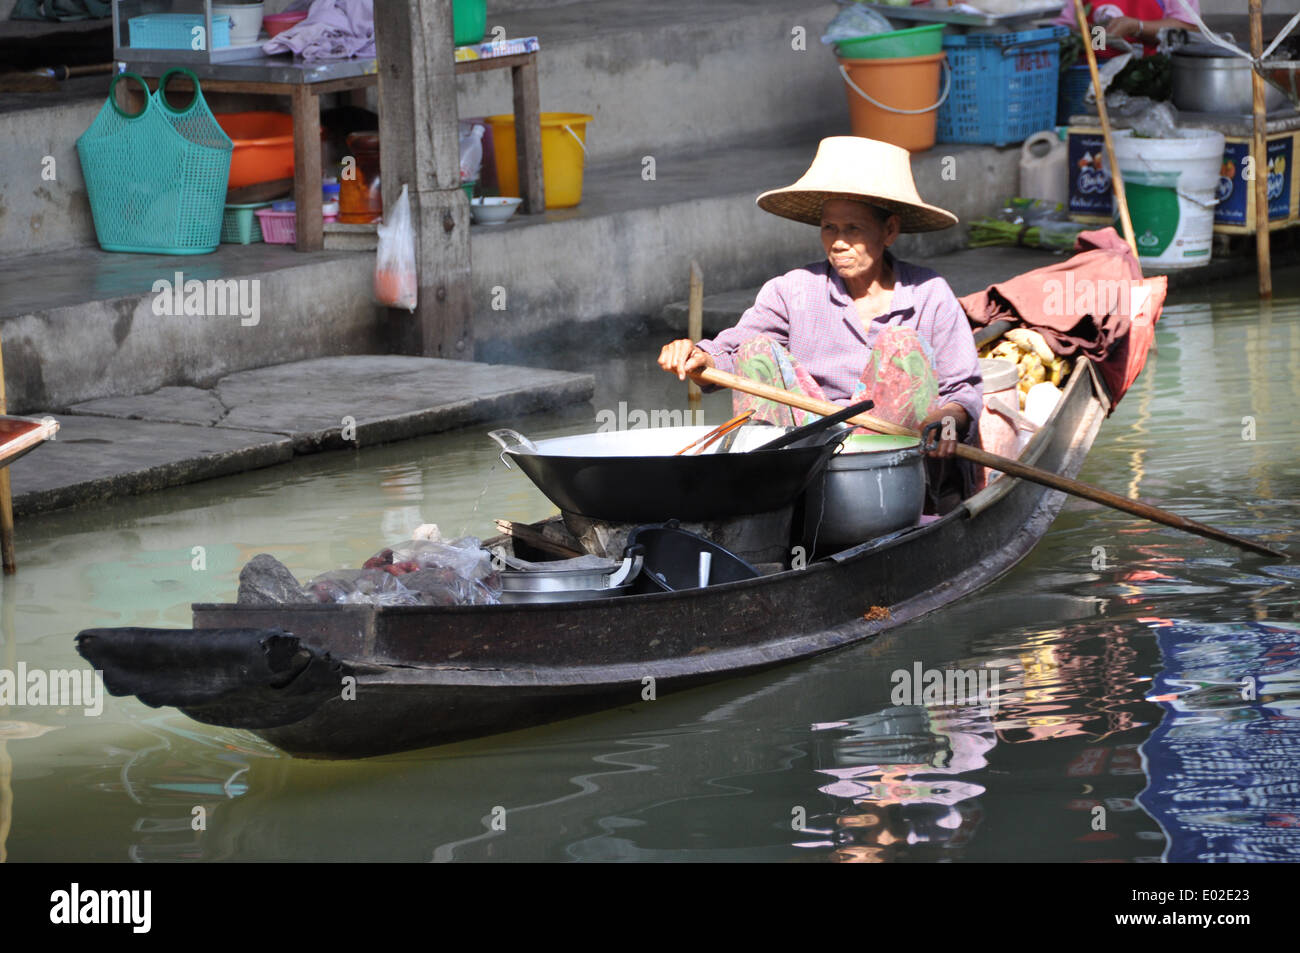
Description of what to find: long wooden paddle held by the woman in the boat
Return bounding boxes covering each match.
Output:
[689,368,1290,559]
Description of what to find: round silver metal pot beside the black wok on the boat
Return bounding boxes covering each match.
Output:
[803,434,926,553]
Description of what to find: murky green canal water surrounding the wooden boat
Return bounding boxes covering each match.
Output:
[0,270,1300,862]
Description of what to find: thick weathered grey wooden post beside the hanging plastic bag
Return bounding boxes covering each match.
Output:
[374,0,475,360]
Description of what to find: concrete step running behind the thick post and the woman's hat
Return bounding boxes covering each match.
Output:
[0,135,1017,412]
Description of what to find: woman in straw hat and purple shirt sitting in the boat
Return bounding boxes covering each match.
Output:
[659,137,983,495]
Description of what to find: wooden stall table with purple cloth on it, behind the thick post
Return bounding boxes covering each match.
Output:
[122,52,546,251]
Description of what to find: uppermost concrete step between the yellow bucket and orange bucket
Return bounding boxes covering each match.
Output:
[459,0,846,163]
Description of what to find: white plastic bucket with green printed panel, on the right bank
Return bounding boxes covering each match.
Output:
[1114,129,1223,268]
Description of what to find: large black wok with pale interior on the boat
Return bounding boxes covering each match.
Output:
[489,425,841,523]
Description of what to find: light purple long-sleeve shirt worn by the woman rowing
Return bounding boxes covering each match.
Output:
[699,252,984,433]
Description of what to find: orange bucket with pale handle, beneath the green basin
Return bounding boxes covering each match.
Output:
[840,53,953,152]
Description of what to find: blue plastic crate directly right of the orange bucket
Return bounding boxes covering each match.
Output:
[937,26,1069,146]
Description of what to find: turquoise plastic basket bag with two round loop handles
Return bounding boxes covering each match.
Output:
[77,69,231,255]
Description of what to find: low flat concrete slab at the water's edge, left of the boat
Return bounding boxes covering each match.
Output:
[12,355,595,515]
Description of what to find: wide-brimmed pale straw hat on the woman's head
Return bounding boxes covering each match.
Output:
[758,135,957,231]
